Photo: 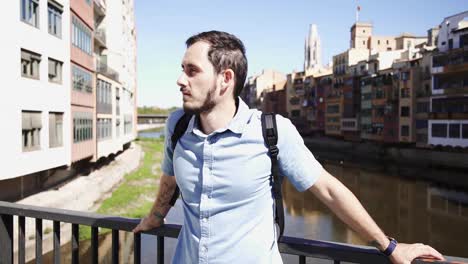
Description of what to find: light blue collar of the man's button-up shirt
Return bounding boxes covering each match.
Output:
[185,97,252,135]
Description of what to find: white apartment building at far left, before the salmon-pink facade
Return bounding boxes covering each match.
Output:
[0,0,71,180]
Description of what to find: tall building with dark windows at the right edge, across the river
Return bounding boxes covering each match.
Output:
[428,11,468,147]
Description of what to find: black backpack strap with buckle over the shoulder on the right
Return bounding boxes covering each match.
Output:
[262,113,284,240]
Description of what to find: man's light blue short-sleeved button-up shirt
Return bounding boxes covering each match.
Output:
[162,99,323,264]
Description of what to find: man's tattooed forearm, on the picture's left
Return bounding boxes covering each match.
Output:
[150,174,177,220]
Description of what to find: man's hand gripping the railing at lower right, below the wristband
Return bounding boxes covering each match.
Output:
[390,243,445,264]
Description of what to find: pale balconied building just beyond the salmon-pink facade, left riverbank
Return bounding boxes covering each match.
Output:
[95,0,136,158]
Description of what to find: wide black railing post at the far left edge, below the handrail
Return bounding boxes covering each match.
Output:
[0,214,13,264]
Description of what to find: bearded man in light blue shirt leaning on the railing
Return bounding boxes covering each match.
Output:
[134,31,443,263]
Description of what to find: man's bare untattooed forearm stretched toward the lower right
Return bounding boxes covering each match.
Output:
[310,171,389,250]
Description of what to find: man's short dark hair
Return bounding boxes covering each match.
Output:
[185,30,247,98]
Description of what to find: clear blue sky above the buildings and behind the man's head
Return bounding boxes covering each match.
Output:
[135,0,468,107]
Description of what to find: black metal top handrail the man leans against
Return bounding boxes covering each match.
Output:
[0,201,462,264]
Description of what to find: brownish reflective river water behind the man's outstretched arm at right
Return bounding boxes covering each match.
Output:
[284,162,468,257]
